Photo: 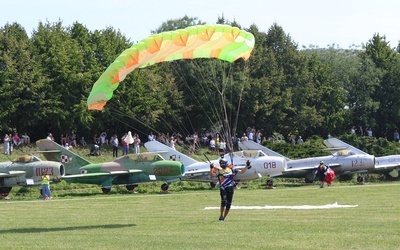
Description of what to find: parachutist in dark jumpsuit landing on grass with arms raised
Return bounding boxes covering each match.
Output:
[210,158,251,221]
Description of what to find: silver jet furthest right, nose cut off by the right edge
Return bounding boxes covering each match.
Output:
[324,138,400,179]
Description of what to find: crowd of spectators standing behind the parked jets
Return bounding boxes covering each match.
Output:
[3,122,400,154]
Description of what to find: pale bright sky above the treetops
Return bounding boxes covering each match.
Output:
[0,0,400,48]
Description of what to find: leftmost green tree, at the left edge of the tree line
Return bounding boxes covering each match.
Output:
[0,23,45,134]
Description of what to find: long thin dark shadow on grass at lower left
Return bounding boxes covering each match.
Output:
[0,224,136,234]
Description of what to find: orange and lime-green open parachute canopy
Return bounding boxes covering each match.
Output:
[87,24,254,110]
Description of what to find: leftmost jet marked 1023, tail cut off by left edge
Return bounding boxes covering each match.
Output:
[0,155,65,199]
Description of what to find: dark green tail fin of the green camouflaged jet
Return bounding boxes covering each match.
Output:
[36,139,91,175]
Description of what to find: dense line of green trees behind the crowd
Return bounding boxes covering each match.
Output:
[0,16,400,143]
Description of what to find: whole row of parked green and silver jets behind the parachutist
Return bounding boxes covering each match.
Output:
[0,138,400,197]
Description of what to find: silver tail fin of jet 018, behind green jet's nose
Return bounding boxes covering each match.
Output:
[144,141,198,166]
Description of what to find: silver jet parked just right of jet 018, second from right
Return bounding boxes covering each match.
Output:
[239,138,375,183]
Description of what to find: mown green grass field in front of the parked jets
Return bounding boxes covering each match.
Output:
[0,182,400,249]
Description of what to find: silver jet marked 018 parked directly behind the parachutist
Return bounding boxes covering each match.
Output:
[144,141,286,187]
